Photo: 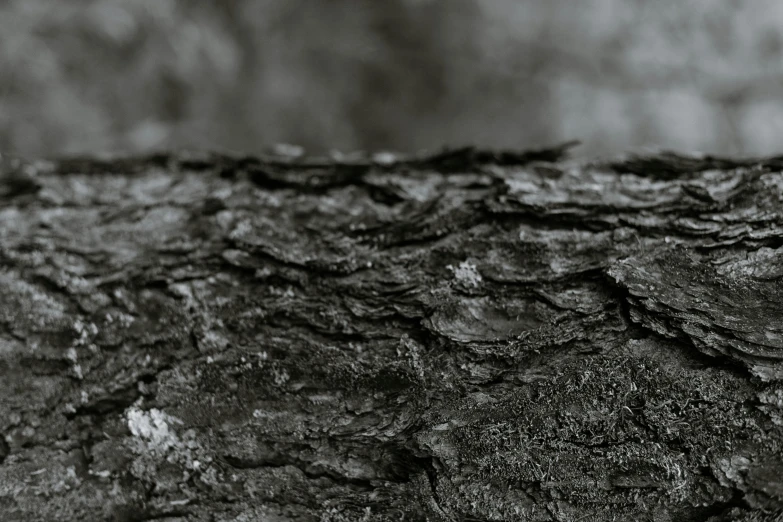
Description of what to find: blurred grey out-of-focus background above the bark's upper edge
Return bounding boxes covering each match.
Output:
[0,0,783,157]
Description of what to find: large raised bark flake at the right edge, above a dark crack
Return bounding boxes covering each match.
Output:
[609,248,783,380]
